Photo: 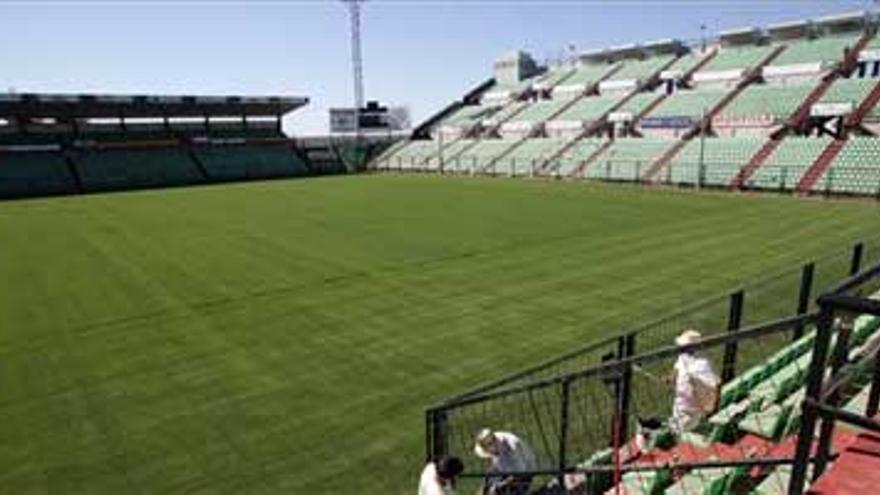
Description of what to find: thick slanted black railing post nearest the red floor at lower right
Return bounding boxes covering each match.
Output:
[788,303,834,495]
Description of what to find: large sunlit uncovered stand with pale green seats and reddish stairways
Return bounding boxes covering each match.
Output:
[375,13,880,197]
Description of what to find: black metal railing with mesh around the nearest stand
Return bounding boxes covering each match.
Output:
[426,243,880,493]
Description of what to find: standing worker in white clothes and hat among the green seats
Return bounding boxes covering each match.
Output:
[670,330,721,433]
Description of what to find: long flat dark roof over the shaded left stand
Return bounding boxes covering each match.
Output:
[0,93,309,119]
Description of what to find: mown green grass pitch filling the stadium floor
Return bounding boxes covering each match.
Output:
[0,175,880,495]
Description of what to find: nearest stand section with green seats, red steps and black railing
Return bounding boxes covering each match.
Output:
[426,240,880,495]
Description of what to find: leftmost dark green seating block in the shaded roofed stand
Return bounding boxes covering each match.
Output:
[0,151,77,198]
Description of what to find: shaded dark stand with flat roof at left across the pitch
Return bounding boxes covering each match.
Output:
[0,93,394,198]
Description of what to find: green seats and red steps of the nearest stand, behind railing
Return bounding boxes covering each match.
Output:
[584,315,880,495]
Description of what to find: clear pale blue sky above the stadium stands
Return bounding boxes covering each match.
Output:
[0,0,873,134]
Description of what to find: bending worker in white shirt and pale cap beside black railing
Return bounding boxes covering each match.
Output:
[474,428,537,495]
